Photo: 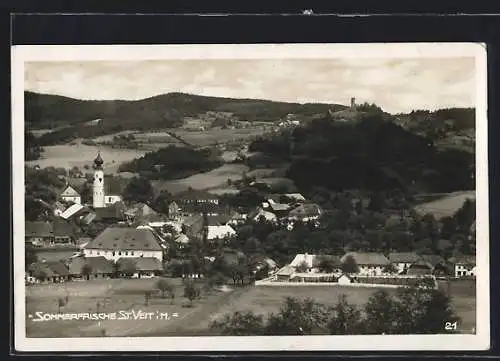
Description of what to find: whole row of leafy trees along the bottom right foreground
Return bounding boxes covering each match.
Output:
[210,278,460,336]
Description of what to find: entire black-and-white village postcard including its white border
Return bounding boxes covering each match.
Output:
[12,43,490,351]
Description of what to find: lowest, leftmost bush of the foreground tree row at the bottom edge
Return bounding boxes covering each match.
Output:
[210,311,265,336]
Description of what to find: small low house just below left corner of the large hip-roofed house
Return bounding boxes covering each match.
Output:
[68,256,116,280]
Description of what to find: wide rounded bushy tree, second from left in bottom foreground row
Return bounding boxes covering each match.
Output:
[266,297,328,335]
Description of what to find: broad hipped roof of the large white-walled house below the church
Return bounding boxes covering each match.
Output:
[85,227,162,251]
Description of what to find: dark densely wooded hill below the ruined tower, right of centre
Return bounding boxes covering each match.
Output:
[250,113,475,192]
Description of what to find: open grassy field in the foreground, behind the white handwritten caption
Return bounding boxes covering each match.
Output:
[26,279,475,337]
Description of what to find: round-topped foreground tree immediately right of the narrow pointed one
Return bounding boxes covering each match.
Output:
[365,290,395,335]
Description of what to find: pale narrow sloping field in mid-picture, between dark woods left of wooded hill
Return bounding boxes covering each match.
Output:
[153,164,248,194]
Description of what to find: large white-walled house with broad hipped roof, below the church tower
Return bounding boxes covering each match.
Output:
[83,227,163,262]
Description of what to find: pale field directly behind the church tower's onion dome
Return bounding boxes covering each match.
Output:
[26,144,146,173]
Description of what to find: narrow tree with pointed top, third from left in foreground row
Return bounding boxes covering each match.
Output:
[327,295,362,335]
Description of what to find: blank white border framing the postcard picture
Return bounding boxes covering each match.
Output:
[11,43,490,351]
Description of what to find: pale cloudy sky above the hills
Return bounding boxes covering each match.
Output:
[25,57,476,113]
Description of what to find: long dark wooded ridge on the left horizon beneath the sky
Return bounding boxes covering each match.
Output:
[24,91,345,129]
